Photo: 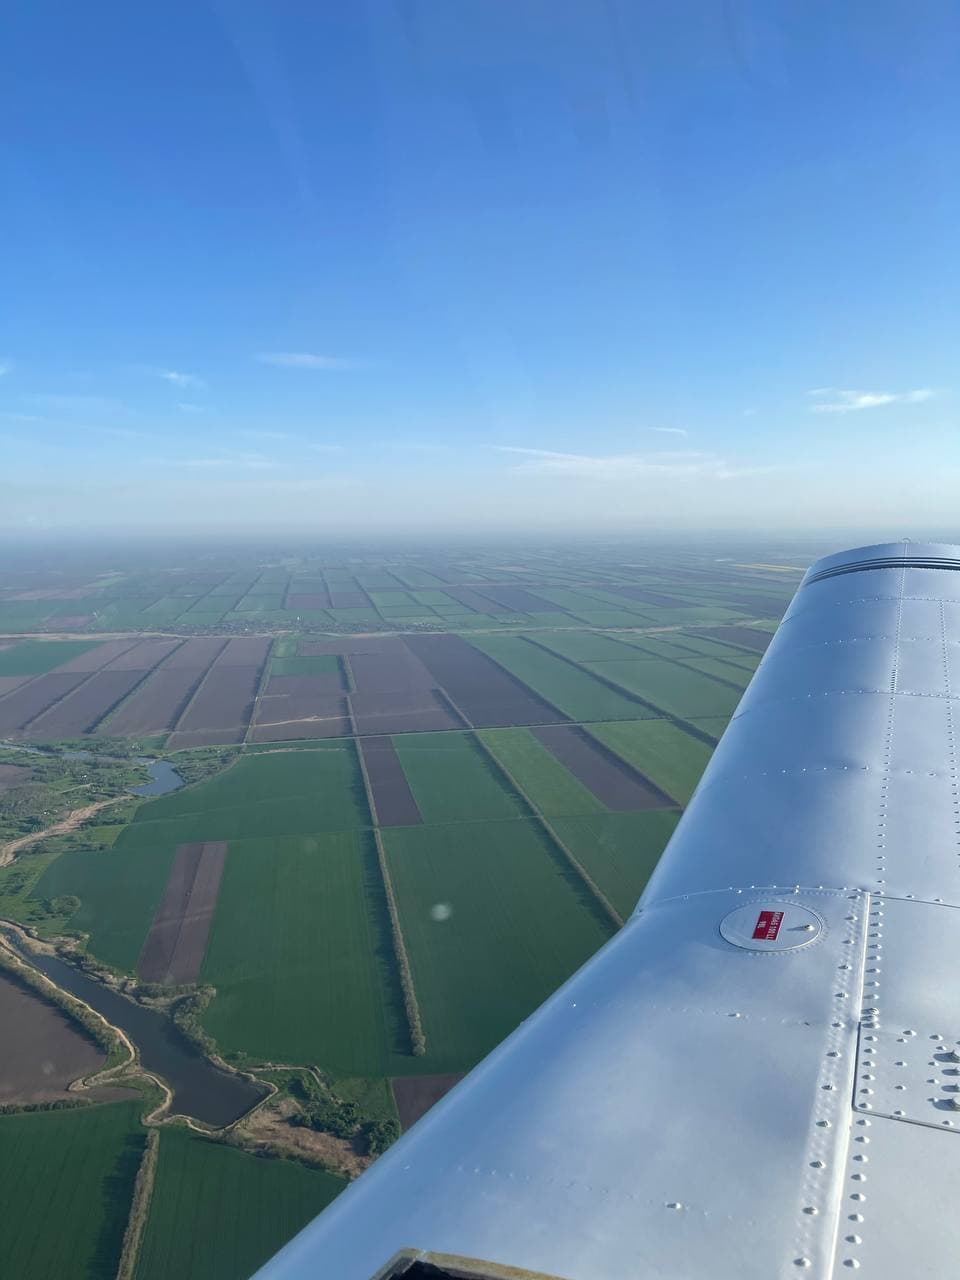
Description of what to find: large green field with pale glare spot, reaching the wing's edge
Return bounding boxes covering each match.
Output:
[384,822,611,1073]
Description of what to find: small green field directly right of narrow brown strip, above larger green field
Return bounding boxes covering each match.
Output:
[393,733,526,822]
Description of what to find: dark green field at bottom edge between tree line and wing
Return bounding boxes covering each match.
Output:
[136,1129,346,1280]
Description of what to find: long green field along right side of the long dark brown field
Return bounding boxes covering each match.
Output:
[470,636,650,721]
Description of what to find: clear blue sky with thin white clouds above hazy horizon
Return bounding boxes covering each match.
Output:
[0,0,960,536]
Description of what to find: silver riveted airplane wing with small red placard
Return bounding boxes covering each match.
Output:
[259,543,960,1280]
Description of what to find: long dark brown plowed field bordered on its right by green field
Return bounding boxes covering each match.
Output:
[404,635,570,728]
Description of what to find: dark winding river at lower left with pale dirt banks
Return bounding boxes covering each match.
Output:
[4,931,266,1129]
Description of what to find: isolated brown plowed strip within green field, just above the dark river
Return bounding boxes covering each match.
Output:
[137,840,227,986]
